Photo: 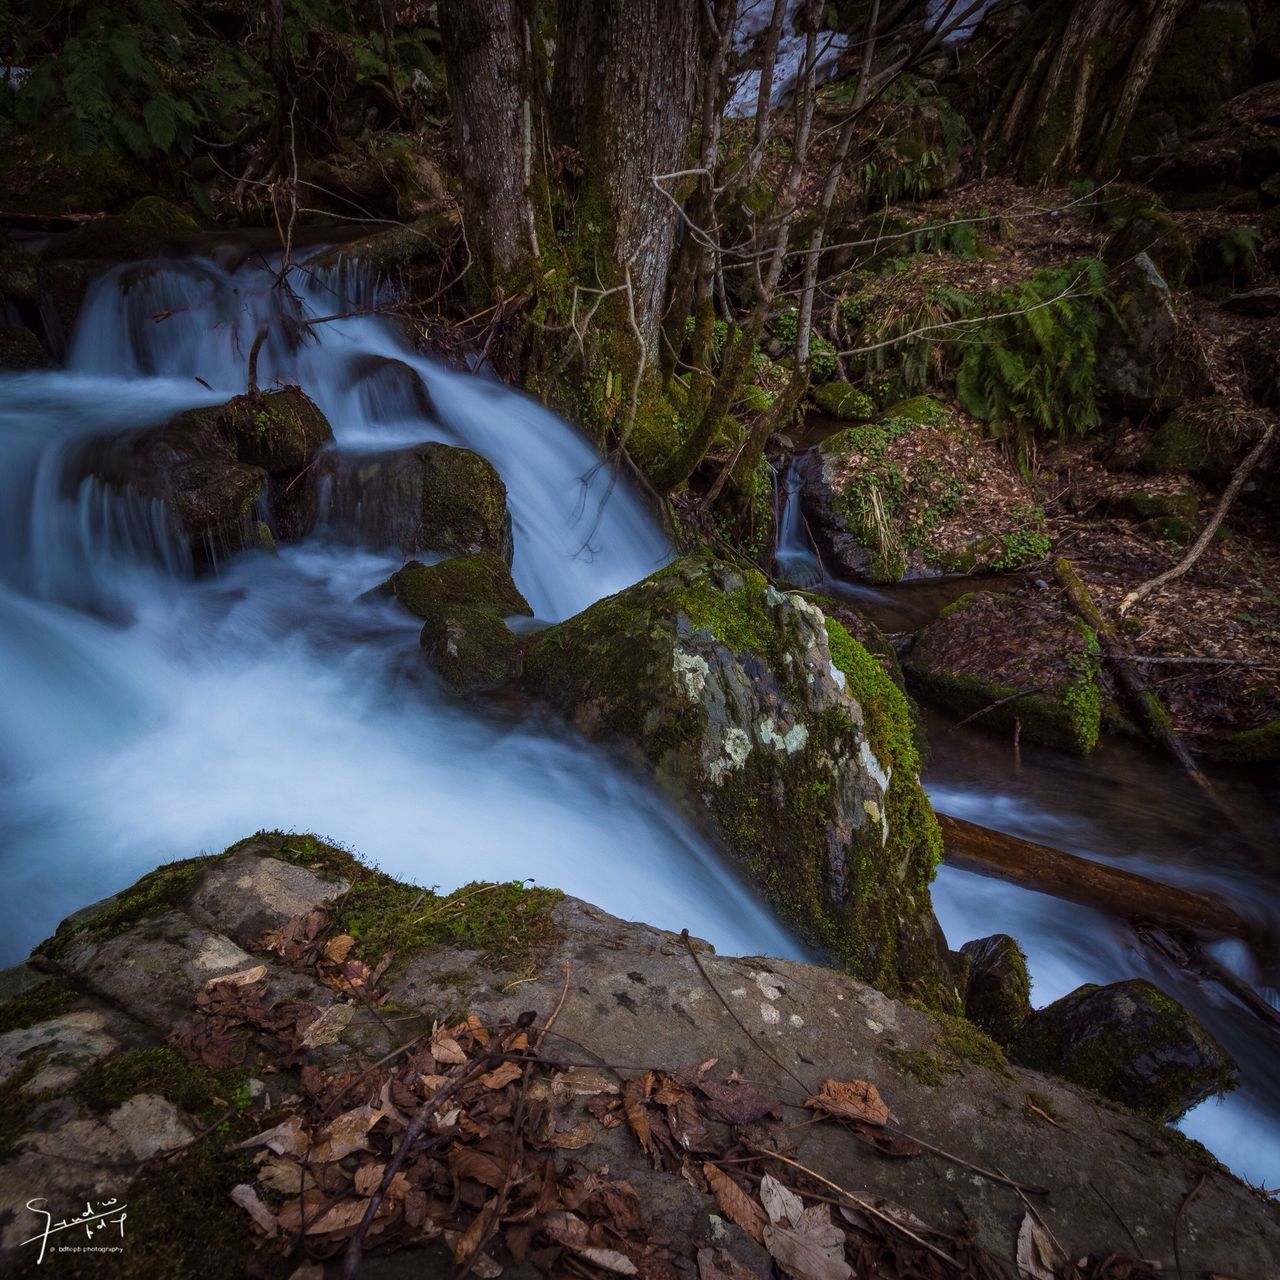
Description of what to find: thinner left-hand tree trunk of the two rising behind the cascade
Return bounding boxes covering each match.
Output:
[439,0,543,290]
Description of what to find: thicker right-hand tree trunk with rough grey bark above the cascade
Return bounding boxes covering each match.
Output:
[552,0,700,353]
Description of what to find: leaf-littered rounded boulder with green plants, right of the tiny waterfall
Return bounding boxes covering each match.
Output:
[800,396,1048,582]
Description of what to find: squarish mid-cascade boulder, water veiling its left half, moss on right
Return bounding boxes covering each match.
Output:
[316,443,512,564]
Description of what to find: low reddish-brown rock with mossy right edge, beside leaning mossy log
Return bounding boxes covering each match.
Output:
[902,590,1102,755]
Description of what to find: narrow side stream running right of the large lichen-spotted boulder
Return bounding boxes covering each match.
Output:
[777,460,1280,1188]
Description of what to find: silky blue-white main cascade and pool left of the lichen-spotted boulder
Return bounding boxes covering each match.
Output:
[0,252,801,963]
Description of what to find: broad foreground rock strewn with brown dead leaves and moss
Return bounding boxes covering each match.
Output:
[0,835,1280,1280]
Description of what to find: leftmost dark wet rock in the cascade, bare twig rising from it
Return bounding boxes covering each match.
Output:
[90,387,333,562]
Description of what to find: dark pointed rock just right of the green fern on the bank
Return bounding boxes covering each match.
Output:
[1097,253,1213,410]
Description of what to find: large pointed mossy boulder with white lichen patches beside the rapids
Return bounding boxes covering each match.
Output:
[525,557,954,1006]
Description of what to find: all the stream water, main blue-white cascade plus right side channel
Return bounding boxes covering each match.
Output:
[0,247,1280,1185]
